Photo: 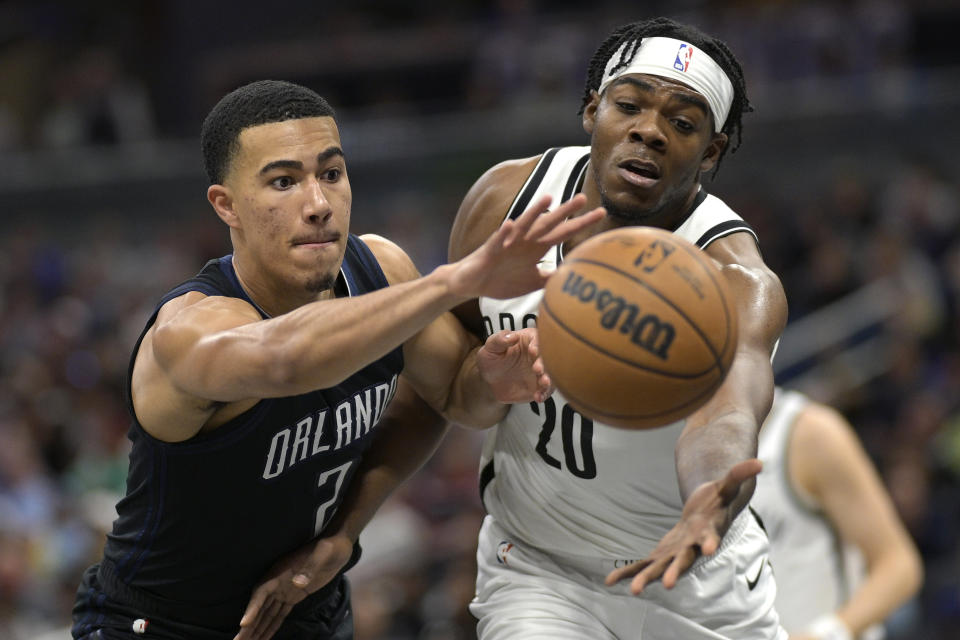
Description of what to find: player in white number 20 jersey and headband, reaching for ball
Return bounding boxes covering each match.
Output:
[450,18,786,640]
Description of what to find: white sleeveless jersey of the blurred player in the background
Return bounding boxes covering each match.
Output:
[750,387,883,640]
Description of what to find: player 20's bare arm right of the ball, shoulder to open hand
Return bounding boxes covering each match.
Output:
[607,233,786,594]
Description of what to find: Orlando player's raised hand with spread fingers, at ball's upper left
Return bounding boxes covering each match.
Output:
[450,194,606,299]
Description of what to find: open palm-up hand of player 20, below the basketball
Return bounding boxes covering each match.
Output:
[606,458,763,595]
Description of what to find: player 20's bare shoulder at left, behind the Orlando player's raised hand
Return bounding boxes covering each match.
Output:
[448,154,543,261]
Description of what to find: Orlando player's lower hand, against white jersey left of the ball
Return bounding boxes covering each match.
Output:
[477,327,553,404]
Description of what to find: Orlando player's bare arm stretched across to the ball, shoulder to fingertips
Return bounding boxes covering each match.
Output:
[133,190,602,441]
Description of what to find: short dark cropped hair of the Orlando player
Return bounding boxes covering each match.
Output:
[200,80,336,184]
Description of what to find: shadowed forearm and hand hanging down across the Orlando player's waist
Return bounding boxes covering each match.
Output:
[235,376,447,640]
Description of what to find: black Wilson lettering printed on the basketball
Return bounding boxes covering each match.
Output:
[561,271,677,360]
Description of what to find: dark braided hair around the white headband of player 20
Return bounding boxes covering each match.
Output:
[578,17,753,173]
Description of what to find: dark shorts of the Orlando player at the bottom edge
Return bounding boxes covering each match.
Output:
[71,565,353,640]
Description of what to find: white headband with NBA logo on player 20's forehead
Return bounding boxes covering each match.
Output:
[598,37,733,131]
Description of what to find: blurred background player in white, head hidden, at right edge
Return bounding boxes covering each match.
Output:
[751,388,923,640]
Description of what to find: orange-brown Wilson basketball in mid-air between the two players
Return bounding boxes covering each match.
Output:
[537,227,737,429]
